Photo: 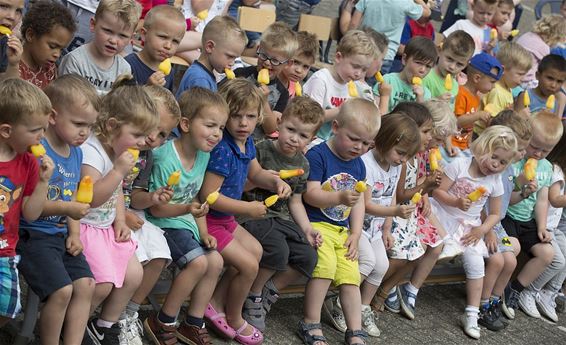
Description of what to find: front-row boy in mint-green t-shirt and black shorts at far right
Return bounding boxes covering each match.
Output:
[501,111,563,317]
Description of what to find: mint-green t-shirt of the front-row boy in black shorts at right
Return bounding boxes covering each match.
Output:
[507,159,552,222]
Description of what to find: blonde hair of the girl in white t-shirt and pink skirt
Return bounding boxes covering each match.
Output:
[94,74,159,140]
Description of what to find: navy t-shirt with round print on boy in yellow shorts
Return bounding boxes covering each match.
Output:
[304,142,366,227]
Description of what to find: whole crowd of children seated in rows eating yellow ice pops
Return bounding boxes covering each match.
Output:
[0,0,566,345]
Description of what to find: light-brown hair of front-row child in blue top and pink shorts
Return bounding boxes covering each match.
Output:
[218,78,265,123]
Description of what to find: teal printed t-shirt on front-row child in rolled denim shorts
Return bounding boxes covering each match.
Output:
[146,140,210,241]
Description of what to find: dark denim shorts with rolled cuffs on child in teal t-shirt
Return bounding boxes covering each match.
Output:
[163,228,209,269]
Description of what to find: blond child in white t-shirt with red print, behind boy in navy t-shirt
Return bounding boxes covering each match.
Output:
[304,30,377,144]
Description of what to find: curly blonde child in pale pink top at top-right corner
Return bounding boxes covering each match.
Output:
[516,15,566,88]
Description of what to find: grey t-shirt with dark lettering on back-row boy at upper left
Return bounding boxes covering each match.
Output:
[59,44,132,95]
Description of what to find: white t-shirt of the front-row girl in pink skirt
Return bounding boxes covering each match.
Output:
[81,134,122,228]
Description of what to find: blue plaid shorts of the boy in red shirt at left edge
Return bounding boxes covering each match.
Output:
[0,255,22,319]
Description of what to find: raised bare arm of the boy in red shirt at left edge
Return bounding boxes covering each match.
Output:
[22,155,55,222]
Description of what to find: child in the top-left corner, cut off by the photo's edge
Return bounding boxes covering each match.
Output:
[0,0,24,81]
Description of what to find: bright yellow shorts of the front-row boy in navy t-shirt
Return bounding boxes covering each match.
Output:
[311,222,360,286]
